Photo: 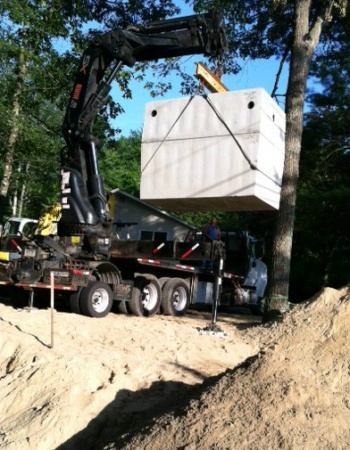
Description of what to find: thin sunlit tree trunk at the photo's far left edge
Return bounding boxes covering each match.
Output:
[0,48,27,222]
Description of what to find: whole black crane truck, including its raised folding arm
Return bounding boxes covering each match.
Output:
[0,11,266,317]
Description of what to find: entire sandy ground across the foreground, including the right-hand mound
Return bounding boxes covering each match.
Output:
[0,287,350,450]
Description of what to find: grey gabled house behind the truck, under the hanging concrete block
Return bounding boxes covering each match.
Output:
[108,189,197,241]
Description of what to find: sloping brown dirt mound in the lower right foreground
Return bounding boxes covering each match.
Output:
[102,287,350,450]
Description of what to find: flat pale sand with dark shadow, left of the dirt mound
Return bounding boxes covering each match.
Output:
[0,303,259,450]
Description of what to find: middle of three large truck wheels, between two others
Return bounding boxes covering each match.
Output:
[129,274,162,317]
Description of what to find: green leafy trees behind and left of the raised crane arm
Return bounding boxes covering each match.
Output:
[0,0,191,220]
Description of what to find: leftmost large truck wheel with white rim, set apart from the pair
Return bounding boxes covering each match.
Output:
[79,281,113,317]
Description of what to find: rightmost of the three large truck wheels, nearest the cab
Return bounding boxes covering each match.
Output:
[162,278,190,316]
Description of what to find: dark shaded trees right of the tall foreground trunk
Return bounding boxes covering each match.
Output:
[290,26,350,299]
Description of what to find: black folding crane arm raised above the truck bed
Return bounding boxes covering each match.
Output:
[58,11,226,236]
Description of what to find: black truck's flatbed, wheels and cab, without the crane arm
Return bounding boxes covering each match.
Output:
[0,233,266,317]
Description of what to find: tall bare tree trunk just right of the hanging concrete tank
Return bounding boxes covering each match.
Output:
[264,0,324,321]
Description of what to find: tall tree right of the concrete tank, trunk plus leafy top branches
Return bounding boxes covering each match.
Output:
[193,0,347,320]
